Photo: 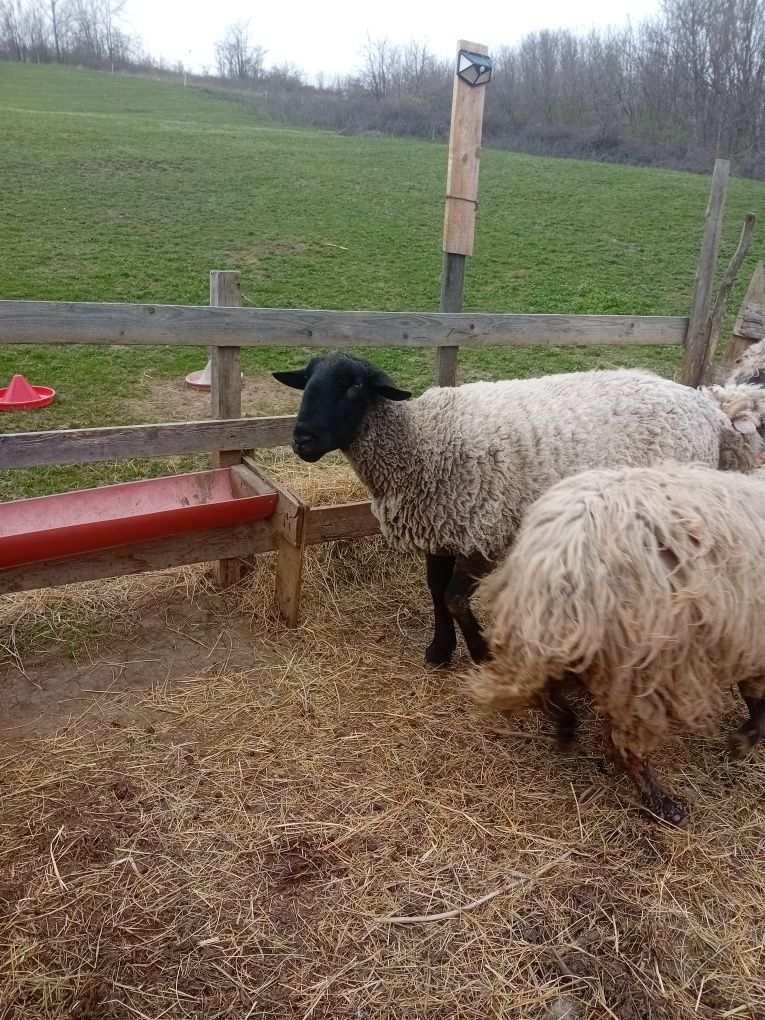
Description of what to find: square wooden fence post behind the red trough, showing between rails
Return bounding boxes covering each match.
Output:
[210,269,242,587]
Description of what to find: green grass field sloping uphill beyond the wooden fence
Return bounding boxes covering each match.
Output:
[0,63,765,499]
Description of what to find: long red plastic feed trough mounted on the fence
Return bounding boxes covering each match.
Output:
[0,467,278,568]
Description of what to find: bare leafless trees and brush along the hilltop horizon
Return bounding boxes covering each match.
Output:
[0,0,765,177]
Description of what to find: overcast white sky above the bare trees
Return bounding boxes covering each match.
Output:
[122,0,659,79]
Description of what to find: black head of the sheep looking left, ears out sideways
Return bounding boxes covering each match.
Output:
[273,351,411,462]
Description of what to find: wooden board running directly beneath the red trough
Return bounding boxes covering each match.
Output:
[0,520,276,595]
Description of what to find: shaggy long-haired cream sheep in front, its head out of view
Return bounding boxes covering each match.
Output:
[466,464,765,825]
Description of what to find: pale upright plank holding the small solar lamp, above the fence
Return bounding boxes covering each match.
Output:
[444,39,488,255]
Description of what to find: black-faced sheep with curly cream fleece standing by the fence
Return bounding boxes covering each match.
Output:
[273,352,754,665]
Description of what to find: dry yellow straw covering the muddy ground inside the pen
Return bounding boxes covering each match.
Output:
[0,455,765,1020]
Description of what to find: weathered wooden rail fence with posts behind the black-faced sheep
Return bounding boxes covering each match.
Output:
[0,185,765,625]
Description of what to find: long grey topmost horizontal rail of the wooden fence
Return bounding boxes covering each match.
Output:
[0,301,689,348]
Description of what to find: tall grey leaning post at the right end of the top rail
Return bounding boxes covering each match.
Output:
[679,159,730,386]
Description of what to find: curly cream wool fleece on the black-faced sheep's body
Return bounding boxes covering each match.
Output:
[346,369,730,560]
